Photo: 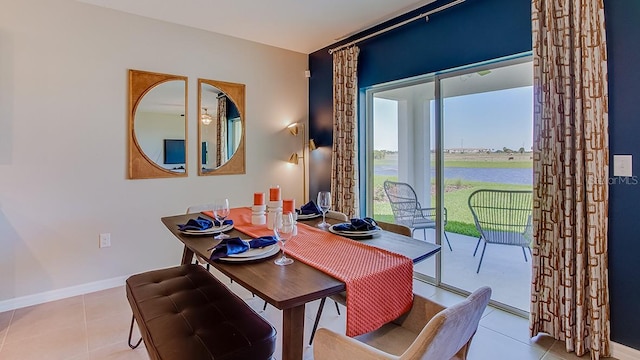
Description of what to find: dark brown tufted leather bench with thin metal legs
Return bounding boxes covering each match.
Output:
[126,264,276,360]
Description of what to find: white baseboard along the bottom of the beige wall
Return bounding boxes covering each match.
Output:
[0,276,128,313]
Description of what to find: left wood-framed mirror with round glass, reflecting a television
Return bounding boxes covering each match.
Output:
[128,70,189,179]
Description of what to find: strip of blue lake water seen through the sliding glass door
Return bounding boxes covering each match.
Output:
[373,166,533,185]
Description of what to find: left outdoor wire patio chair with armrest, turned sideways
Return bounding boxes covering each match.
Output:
[384,180,453,251]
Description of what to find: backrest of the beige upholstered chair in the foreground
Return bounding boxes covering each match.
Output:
[400,286,491,359]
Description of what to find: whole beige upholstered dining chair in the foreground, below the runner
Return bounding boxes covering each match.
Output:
[313,286,491,360]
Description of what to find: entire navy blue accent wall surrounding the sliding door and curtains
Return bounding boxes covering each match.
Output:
[309,0,640,349]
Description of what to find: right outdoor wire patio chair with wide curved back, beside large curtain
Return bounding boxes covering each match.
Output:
[469,189,532,273]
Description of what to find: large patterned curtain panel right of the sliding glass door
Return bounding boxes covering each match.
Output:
[530,0,611,359]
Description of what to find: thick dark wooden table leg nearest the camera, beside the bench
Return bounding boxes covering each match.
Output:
[282,304,304,360]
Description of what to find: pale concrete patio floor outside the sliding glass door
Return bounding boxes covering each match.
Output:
[414,230,531,312]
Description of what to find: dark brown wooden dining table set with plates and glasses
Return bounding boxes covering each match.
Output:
[161,214,440,360]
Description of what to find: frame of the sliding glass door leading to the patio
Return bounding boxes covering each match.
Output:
[359,51,533,318]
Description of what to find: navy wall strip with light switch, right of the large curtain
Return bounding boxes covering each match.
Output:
[605,0,640,349]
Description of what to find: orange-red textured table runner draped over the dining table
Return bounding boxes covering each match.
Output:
[205,208,413,336]
